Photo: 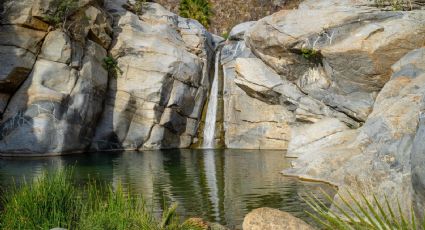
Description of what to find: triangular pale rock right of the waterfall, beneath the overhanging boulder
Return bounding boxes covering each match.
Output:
[221,22,360,149]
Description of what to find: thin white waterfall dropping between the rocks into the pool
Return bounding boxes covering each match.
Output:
[203,51,221,149]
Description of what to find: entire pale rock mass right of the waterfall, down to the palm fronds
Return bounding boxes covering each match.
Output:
[222,0,425,215]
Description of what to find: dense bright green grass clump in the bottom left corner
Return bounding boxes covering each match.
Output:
[0,170,82,229]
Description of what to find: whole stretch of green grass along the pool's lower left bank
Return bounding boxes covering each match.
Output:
[0,169,201,230]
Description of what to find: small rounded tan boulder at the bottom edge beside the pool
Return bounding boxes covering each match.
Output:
[243,208,314,230]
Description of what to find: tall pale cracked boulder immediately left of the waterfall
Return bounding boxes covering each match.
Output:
[92,1,214,150]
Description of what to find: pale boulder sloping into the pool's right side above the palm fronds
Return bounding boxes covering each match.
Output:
[284,48,425,216]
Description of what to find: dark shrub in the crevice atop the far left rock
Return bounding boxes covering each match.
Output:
[43,0,78,28]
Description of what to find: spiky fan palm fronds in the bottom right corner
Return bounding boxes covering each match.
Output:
[305,191,425,230]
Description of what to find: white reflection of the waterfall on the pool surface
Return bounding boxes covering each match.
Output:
[204,150,220,221]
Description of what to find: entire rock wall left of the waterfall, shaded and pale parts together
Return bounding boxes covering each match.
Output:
[0,0,214,156]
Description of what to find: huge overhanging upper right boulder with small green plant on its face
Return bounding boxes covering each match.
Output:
[245,4,425,121]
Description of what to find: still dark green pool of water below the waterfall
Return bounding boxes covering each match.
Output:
[0,150,330,229]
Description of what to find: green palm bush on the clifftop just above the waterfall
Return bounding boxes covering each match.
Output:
[179,0,212,28]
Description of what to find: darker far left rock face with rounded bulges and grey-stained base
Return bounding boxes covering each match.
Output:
[0,0,110,155]
